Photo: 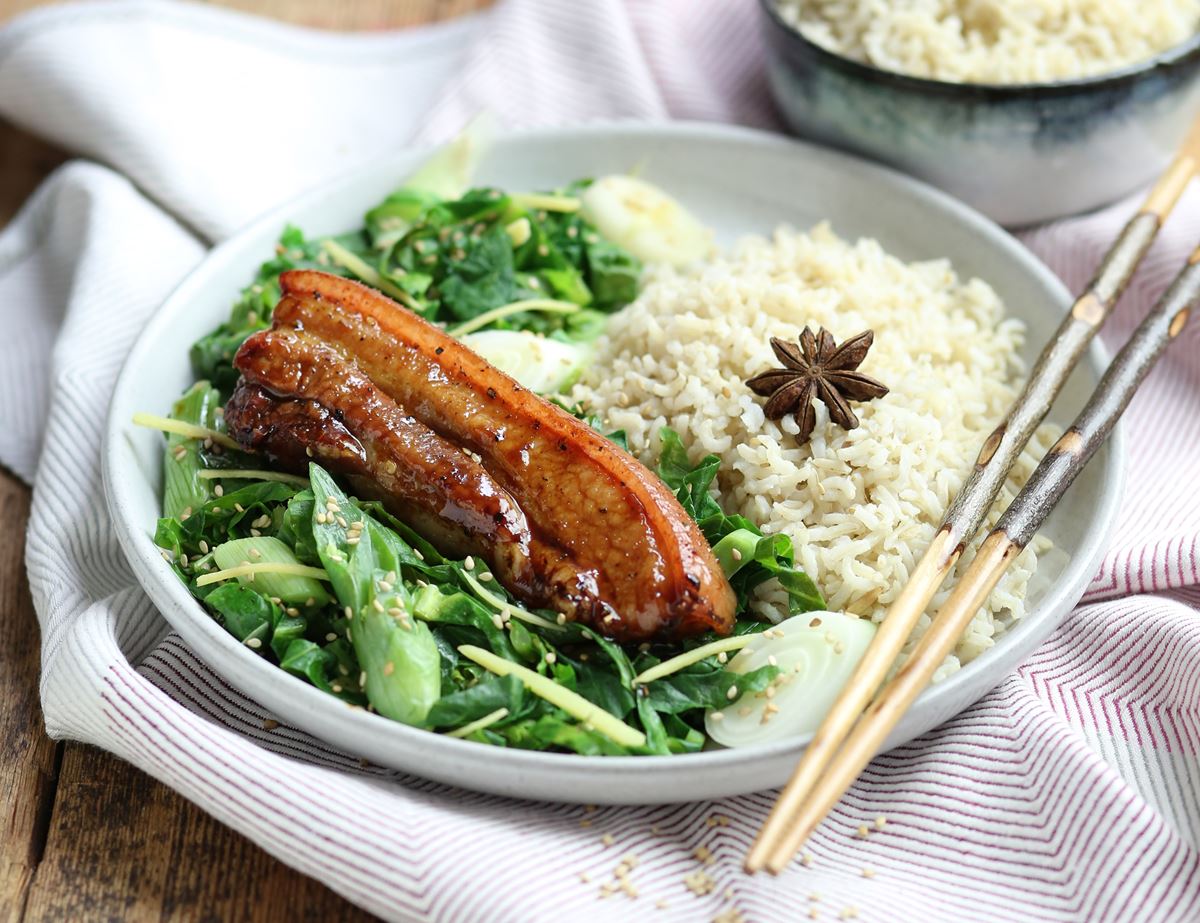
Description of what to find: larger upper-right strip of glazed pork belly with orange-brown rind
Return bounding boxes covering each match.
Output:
[224,271,734,641]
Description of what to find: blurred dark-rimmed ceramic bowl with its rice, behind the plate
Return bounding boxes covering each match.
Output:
[760,0,1200,227]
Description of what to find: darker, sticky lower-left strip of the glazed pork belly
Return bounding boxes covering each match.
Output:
[226,329,592,605]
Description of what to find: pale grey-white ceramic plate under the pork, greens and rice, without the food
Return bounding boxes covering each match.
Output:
[103,125,1120,803]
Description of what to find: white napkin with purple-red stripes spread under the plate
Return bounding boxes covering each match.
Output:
[0,0,1200,921]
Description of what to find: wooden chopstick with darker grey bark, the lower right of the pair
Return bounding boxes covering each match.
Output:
[766,240,1200,873]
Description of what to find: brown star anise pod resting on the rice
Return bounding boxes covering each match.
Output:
[746,326,888,442]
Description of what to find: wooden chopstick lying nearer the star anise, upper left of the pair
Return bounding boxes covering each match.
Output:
[745,119,1200,873]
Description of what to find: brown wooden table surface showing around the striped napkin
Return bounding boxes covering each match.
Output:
[0,0,490,923]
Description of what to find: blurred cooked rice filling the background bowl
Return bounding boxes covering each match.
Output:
[779,0,1200,84]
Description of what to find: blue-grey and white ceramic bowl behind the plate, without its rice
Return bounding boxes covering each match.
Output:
[760,0,1200,227]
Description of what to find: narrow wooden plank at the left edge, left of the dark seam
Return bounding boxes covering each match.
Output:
[0,469,59,923]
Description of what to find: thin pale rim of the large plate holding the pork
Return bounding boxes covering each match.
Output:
[101,120,1124,804]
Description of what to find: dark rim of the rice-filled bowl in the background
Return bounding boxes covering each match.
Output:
[758,0,1200,102]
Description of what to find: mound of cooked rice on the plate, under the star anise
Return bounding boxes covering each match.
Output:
[572,224,1052,675]
